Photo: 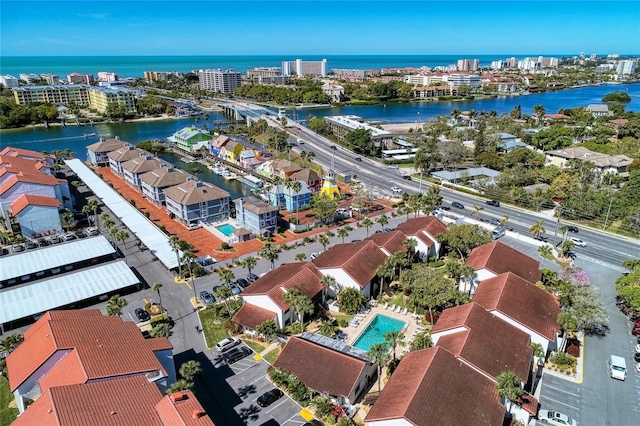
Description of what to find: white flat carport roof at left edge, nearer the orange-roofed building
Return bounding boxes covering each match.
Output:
[0,260,140,331]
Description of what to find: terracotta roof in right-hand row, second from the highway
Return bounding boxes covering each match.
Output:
[473,272,560,341]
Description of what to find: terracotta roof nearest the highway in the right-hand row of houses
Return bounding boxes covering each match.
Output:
[465,241,542,283]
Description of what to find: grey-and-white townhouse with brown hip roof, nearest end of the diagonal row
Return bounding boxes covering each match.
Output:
[163,176,230,229]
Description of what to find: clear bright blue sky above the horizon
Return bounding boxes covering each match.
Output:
[0,0,640,56]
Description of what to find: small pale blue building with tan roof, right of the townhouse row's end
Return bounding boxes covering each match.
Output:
[233,196,278,238]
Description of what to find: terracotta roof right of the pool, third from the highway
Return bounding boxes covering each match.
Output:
[431,303,532,382]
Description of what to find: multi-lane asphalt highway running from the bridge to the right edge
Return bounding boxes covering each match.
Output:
[288,121,640,271]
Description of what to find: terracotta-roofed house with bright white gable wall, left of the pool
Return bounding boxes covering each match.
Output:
[233,262,323,332]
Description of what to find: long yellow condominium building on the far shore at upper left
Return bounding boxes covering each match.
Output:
[13,84,136,112]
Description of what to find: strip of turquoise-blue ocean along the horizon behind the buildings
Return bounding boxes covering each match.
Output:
[0,54,573,78]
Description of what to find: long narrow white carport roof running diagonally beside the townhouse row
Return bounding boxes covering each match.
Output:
[65,158,181,269]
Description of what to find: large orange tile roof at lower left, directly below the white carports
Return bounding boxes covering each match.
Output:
[7,311,167,391]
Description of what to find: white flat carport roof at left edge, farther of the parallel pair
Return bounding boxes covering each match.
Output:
[0,235,116,287]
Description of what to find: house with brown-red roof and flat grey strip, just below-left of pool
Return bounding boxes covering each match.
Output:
[273,332,376,405]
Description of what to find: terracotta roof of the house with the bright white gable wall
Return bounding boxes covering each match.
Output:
[243,262,323,311]
